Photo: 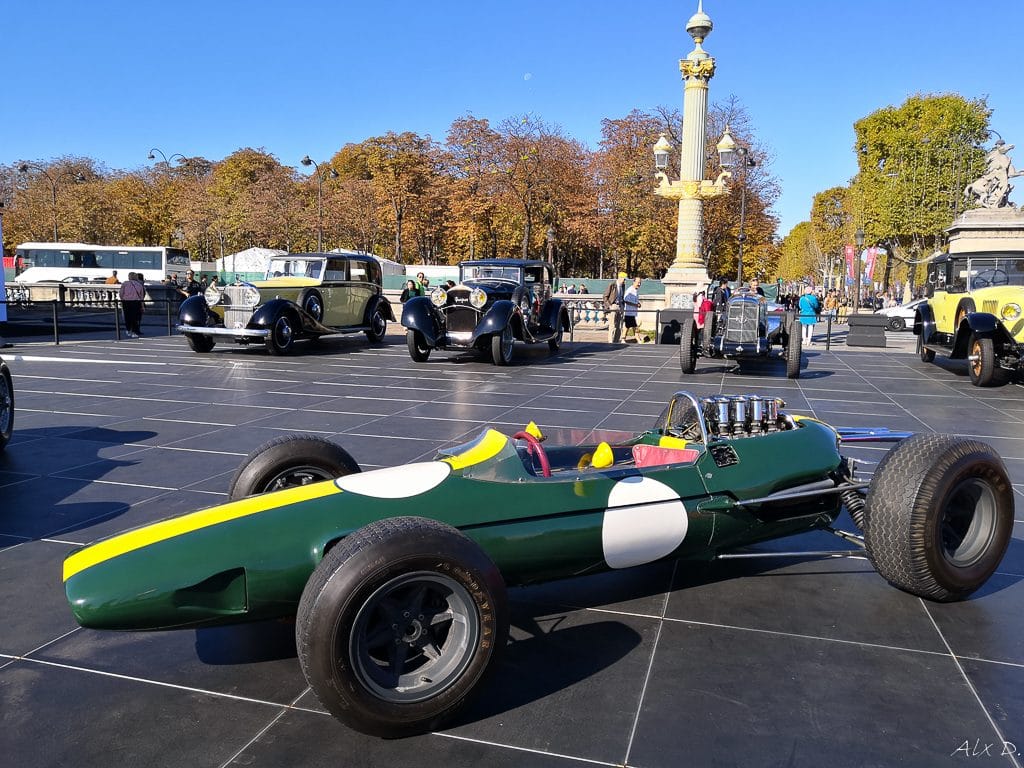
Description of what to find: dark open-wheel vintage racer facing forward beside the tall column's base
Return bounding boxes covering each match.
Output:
[679,291,802,379]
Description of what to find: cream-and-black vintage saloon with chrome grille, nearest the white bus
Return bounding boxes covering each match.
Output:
[178,253,394,354]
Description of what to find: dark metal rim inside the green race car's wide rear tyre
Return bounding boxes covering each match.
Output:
[939,477,998,568]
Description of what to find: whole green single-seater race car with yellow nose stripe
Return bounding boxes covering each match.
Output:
[63,392,1014,737]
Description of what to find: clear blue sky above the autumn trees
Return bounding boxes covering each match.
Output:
[0,0,1024,240]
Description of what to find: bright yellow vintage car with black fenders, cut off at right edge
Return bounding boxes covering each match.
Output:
[913,253,1024,387]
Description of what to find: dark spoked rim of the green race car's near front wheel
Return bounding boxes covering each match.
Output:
[348,571,480,703]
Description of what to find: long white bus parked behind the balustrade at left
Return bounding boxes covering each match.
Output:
[14,243,190,283]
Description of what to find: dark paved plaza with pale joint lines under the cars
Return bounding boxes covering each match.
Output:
[0,327,1024,768]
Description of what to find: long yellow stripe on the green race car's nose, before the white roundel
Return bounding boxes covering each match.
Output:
[63,480,342,582]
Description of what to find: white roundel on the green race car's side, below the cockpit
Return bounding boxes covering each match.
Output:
[601,477,689,568]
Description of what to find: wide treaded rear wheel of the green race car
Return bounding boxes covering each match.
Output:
[864,434,1014,601]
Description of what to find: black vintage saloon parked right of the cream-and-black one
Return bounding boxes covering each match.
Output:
[401,259,570,366]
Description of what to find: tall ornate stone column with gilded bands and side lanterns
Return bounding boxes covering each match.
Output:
[654,0,730,307]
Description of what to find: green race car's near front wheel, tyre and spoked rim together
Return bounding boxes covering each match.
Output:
[295,517,509,738]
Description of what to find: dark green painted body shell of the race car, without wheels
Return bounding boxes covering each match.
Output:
[65,420,842,630]
